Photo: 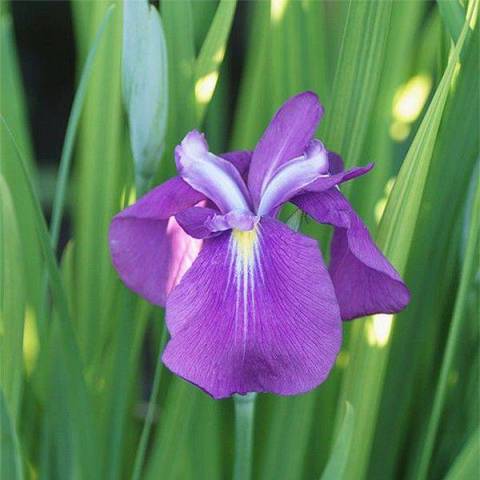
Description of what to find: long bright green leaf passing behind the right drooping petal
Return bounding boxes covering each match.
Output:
[337,8,474,479]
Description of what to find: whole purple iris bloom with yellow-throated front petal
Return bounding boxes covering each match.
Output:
[110,92,409,398]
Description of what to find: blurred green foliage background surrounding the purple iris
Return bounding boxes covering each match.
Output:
[0,0,480,480]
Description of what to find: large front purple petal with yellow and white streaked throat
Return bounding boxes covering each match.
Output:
[163,218,341,398]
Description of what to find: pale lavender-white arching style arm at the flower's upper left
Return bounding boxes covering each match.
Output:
[175,130,251,213]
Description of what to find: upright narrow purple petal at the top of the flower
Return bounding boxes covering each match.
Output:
[248,92,323,206]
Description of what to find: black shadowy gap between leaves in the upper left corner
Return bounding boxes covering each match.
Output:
[10,0,76,168]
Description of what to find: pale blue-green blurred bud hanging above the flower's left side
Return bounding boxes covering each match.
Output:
[122,0,168,185]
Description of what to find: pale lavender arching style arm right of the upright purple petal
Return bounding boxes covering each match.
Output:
[257,140,329,215]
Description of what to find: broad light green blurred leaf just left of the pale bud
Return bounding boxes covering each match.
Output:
[72,2,126,364]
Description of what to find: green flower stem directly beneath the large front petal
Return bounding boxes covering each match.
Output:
[233,393,257,480]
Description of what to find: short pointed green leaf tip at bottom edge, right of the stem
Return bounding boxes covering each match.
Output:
[321,403,355,480]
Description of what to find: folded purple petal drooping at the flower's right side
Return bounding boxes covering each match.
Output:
[292,188,410,320]
